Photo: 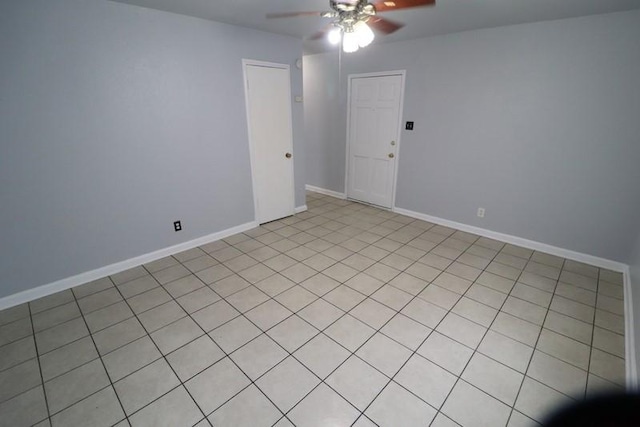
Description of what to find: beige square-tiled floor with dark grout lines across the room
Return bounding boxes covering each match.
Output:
[0,193,624,427]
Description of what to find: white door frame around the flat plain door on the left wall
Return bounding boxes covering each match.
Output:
[242,58,296,223]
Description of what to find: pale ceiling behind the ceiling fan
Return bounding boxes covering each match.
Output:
[113,0,640,53]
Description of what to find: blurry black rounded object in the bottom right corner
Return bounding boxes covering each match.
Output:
[542,393,640,427]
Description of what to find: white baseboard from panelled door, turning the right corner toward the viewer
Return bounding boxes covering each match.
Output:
[393,207,639,390]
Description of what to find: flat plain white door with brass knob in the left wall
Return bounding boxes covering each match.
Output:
[244,61,294,224]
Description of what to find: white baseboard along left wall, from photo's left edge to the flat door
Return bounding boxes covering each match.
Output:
[0,221,258,310]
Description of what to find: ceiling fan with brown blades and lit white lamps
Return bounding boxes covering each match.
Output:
[267,0,436,53]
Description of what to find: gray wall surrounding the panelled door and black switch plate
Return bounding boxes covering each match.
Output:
[304,11,640,262]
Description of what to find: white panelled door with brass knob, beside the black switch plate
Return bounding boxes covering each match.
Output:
[347,74,404,208]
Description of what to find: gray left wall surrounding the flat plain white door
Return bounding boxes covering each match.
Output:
[0,0,305,297]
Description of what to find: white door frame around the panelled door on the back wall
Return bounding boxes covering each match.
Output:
[344,70,407,210]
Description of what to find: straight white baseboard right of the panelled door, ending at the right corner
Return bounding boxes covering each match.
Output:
[393,207,627,273]
